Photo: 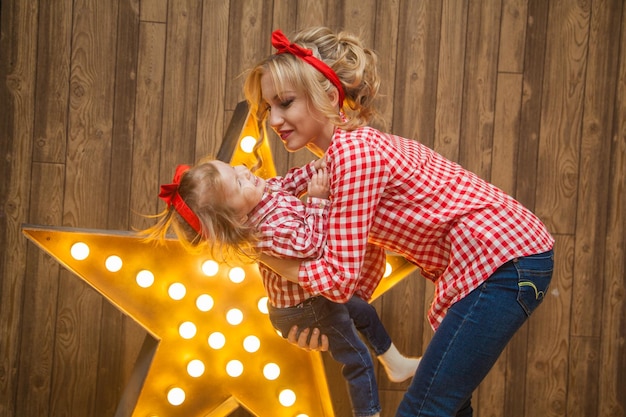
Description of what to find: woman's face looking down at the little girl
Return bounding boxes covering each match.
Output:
[261,73,334,156]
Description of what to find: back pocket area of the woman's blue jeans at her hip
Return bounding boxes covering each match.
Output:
[514,252,554,316]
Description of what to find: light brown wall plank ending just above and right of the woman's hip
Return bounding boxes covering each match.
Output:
[536,0,590,234]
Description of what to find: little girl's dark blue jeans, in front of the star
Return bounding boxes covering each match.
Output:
[269,296,391,417]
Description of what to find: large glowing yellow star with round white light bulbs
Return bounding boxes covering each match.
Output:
[22,104,414,417]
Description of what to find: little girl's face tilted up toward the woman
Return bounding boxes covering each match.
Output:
[212,161,265,217]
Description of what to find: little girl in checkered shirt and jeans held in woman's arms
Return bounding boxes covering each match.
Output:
[147,160,419,416]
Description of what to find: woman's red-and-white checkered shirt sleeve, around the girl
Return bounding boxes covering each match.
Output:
[298,138,389,302]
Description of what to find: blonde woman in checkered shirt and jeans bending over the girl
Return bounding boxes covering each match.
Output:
[244,28,554,417]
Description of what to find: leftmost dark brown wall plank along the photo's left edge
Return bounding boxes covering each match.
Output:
[0,2,38,415]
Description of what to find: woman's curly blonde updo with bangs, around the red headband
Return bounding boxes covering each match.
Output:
[244,27,380,130]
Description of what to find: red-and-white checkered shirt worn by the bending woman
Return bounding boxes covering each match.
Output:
[293,127,554,329]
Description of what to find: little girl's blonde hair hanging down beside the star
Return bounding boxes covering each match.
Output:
[141,158,257,262]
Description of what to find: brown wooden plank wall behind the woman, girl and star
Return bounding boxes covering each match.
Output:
[0,0,626,417]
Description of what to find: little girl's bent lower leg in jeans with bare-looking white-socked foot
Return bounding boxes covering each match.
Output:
[346,295,420,382]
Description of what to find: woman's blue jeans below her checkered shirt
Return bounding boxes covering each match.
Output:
[396,250,554,417]
